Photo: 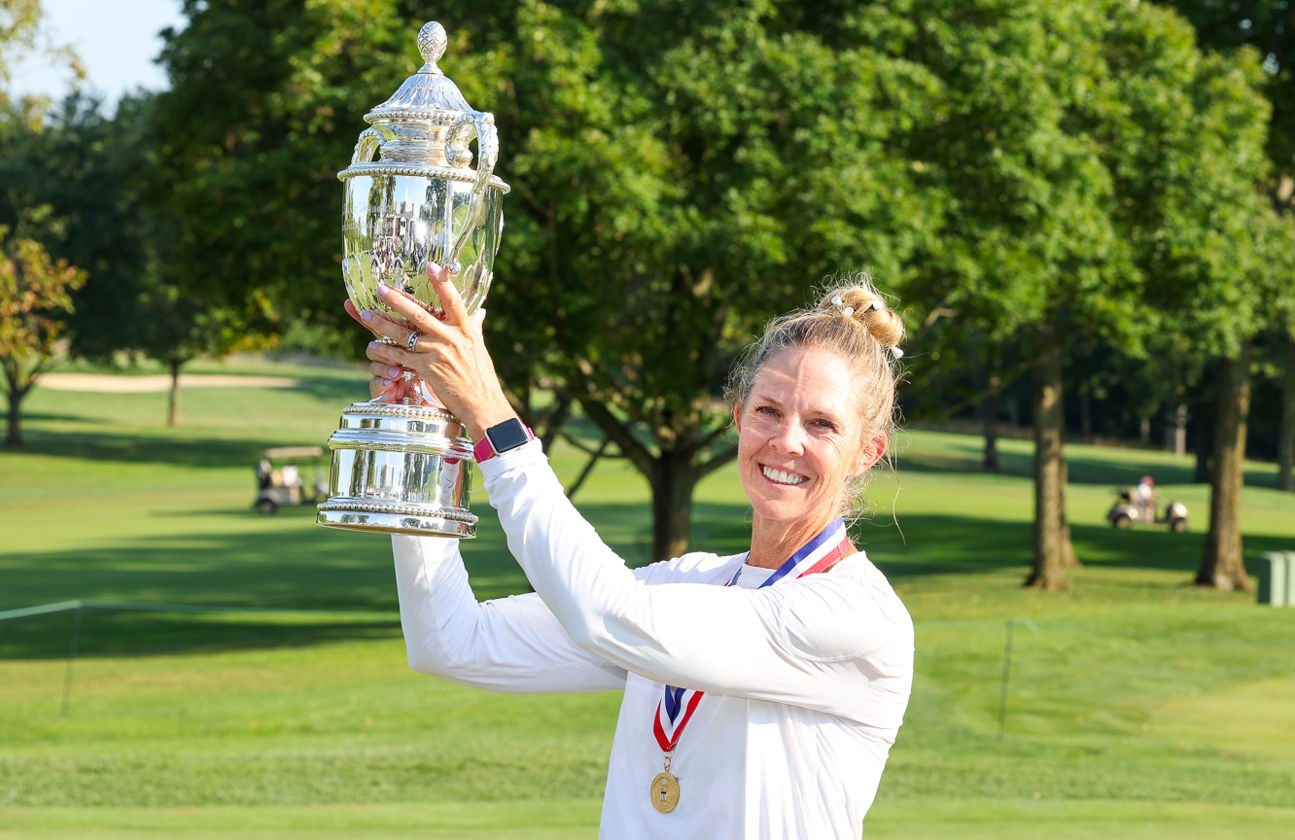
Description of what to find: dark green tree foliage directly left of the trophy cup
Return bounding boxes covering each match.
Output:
[145,0,367,341]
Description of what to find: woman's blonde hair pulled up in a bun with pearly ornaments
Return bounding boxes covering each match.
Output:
[725,272,904,514]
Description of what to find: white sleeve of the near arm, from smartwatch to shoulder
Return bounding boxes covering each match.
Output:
[482,441,913,727]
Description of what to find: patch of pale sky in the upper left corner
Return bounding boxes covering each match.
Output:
[10,0,185,111]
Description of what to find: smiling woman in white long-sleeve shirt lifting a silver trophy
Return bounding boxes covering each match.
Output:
[348,271,913,840]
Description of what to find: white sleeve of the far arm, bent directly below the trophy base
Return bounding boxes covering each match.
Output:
[391,536,625,694]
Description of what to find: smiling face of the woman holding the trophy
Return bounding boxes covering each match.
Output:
[733,347,884,527]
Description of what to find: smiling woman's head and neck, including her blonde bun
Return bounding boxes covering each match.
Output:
[729,274,904,566]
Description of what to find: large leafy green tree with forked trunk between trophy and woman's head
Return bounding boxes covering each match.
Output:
[484,4,929,558]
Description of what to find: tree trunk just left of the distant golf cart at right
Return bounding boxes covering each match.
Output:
[1026,342,1074,591]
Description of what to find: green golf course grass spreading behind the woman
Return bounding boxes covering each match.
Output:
[0,360,1295,840]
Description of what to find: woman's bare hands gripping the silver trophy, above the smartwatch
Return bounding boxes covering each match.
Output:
[346,265,515,440]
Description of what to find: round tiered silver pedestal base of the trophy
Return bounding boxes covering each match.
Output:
[316,403,477,538]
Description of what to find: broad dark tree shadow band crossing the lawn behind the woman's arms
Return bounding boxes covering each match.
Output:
[0,501,1274,659]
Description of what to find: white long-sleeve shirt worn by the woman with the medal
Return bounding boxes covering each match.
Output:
[392,441,913,840]
